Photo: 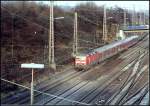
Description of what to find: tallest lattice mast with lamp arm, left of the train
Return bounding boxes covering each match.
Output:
[48,1,56,70]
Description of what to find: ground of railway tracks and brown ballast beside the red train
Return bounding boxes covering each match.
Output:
[2,35,149,105]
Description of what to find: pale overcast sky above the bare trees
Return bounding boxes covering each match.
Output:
[36,1,149,11]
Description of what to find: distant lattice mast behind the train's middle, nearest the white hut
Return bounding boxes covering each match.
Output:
[103,6,107,41]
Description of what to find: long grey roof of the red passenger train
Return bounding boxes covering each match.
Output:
[77,36,138,56]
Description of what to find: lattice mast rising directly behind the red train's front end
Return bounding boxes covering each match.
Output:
[73,12,78,56]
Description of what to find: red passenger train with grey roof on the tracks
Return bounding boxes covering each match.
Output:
[75,36,138,70]
